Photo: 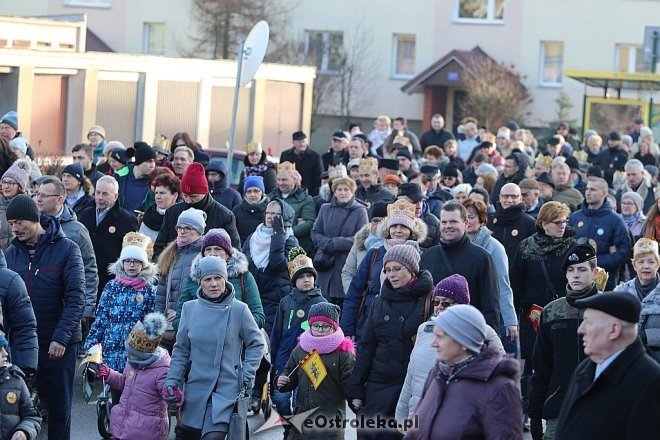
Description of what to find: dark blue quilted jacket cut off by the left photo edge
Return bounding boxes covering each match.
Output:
[0,251,39,370]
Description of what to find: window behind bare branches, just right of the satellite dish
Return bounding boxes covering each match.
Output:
[305,31,344,73]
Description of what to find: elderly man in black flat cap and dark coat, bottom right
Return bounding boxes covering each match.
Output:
[555,292,660,440]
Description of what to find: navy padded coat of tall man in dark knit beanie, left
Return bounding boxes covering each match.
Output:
[5,215,85,347]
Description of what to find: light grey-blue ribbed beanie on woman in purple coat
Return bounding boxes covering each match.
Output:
[433,304,486,353]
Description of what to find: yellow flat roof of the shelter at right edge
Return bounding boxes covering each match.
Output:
[565,70,660,92]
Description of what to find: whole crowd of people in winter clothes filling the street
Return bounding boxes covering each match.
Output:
[0,107,660,440]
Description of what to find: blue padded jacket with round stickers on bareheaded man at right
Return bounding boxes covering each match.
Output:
[568,200,631,288]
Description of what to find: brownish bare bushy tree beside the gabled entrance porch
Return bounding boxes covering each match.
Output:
[460,57,532,129]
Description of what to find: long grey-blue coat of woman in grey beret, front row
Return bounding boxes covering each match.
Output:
[165,283,265,435]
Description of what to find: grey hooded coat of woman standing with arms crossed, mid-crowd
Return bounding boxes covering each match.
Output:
[312,197,369,298]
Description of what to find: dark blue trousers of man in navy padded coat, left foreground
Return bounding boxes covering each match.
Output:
[37,343,78,440]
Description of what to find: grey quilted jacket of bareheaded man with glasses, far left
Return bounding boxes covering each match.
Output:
[58,205,99,318]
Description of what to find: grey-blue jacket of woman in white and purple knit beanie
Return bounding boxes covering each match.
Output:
[156,237,202,313]
